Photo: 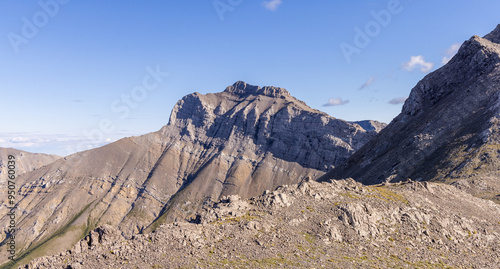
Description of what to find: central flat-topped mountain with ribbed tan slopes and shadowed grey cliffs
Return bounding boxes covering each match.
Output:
[0,82,378,261]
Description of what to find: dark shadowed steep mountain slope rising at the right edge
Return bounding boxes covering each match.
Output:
[319,25,500,202]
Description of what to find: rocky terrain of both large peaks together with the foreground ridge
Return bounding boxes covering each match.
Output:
[1,22,500,269]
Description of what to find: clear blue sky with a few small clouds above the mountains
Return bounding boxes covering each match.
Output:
[0,0,500,155]
